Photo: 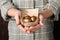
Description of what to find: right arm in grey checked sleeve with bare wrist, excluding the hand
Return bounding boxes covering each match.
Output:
[39,0,60,20]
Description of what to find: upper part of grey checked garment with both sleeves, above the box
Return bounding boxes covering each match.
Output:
[0,0,60,20]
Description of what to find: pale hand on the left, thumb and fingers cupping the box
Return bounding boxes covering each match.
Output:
[14,9,26,32]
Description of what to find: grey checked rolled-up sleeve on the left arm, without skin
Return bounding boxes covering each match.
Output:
[0,0,15,21]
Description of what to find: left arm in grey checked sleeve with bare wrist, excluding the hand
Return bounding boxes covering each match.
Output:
[0,0,19,21]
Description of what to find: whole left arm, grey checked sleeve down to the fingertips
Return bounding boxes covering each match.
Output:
[0,0,26,32]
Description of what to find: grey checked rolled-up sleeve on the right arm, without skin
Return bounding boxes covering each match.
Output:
[44,0,60,21]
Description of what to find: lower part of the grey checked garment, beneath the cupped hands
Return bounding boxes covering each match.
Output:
[8,20,54,40]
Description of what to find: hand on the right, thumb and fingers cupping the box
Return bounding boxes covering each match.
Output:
[27,14,44,33]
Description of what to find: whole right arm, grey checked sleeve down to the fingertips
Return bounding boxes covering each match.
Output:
[27,0,60,32]
